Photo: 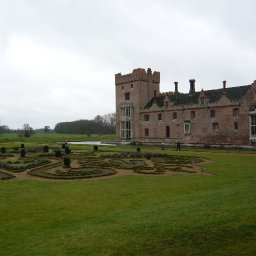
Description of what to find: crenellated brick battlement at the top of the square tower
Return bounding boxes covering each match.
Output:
[115,68,160,85]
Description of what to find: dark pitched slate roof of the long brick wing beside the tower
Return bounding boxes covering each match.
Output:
[145,85,251,109]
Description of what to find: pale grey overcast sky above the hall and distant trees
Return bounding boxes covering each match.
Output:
[0,0,256,128]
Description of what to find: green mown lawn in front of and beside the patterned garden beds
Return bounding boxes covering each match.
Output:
[0,134,256,256]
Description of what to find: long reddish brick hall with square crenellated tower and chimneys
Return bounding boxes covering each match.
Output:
[115,68,256,145]
